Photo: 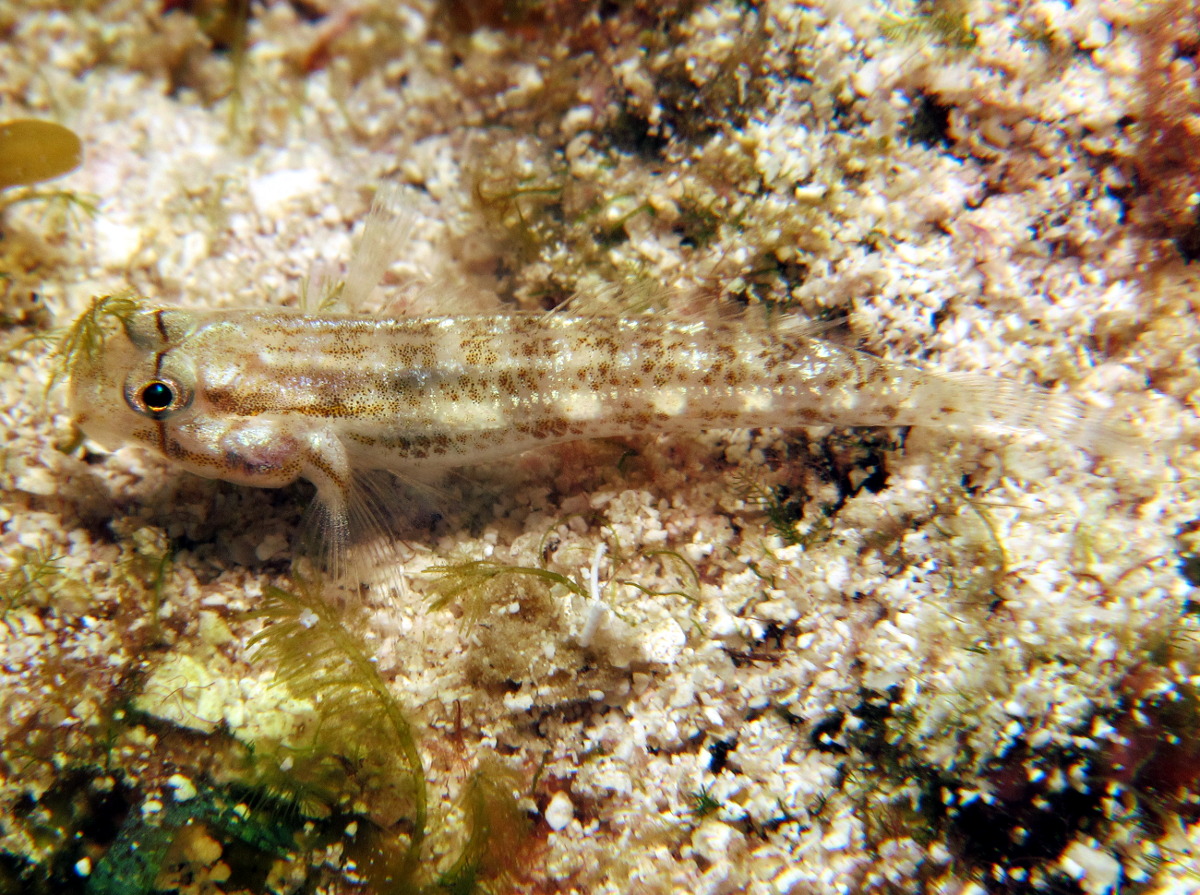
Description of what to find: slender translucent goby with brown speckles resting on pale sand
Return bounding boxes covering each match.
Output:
[61,284,1138,578]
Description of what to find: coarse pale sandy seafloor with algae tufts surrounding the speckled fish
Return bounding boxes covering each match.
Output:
[0,0,1200,895]
